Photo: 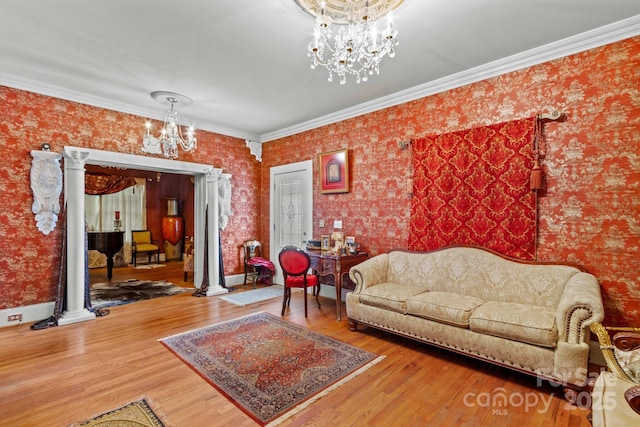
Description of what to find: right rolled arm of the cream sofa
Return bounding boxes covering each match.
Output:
[556,272,604,344]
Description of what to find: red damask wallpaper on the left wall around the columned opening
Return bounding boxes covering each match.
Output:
[0,86,260,309]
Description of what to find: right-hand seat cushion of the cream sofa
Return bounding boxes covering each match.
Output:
[469,301,558,347]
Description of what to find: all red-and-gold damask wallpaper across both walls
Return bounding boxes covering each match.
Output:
[0,37,640,325]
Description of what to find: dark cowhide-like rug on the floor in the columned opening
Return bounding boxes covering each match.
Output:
[91,279,193,309]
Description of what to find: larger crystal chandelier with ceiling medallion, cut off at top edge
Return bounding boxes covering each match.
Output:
[295,0,403,84]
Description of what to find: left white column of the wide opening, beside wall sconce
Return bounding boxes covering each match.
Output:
[58,150,96,326]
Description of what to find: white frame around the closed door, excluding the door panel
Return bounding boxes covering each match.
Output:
[269,160,313,283]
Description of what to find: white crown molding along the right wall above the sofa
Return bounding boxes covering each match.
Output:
[260,15,640,143]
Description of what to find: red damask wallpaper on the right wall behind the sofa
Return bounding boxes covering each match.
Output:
[261,37,640,325]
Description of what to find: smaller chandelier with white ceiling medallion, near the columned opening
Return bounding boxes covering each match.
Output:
[142,91,197,159]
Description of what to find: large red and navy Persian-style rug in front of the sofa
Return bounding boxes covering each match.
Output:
[160,312,383,426]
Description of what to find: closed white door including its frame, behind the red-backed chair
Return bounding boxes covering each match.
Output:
[269,160,313,283]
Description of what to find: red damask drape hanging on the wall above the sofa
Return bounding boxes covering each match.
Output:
[408,117,537,260]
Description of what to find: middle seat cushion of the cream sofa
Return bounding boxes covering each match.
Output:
[407,291,484,328]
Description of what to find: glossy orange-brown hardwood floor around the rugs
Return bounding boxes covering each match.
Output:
[0,262,590,427]
